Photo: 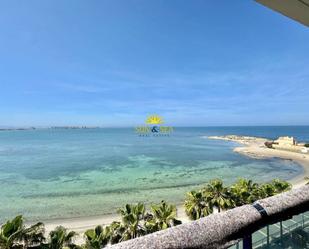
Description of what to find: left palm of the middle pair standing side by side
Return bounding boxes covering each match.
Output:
[118,203,146,241]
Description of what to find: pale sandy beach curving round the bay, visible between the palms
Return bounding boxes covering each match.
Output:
[44,136,309,244]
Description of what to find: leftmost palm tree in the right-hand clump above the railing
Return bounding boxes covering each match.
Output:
[184,191,213,220]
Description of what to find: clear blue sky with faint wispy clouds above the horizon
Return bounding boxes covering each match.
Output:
[0,0,309,126]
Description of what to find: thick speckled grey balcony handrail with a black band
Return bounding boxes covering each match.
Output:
[109,185,309,249]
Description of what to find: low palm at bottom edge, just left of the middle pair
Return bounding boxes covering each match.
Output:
[85,226,111,249]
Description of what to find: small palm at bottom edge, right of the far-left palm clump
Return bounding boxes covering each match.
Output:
[49,226,77,249]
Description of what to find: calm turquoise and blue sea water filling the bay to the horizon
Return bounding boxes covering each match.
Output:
[0,127,309,220]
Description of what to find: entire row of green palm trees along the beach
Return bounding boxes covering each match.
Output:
[0,177,294,249]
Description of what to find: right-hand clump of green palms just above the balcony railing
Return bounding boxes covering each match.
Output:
[184,178,290,220]
